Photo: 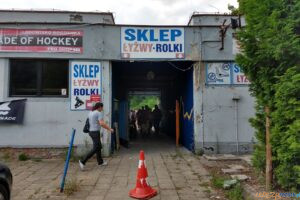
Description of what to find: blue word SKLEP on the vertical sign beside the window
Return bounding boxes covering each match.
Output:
[73,64,100,78]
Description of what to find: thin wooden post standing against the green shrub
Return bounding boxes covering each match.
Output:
[265,106,272,191]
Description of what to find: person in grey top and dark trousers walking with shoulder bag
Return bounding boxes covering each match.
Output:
[79,102,114,170]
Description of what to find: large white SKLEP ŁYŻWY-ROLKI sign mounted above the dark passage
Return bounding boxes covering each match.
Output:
[121,27,184,59]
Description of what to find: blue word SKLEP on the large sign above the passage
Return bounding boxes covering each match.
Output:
[124,28,182,42]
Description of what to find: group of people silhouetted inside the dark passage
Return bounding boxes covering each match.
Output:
[129,105,162,137]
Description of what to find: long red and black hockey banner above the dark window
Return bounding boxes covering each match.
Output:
[0,29,83,53]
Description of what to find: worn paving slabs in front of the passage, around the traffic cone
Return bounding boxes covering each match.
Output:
[7,137,213,200]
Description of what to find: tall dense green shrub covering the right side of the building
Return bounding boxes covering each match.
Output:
[236,0,300,190]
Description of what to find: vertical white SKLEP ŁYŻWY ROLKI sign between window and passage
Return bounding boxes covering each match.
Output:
[70,61,102,110]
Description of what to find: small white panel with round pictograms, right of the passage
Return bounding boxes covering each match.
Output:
[206,63,231,85]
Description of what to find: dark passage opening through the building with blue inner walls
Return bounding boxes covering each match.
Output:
[112,61,194,151]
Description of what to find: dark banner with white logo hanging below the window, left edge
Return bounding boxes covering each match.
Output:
[0,99,26,124]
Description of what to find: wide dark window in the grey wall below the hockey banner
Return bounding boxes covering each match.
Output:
[10,59,69,97]
